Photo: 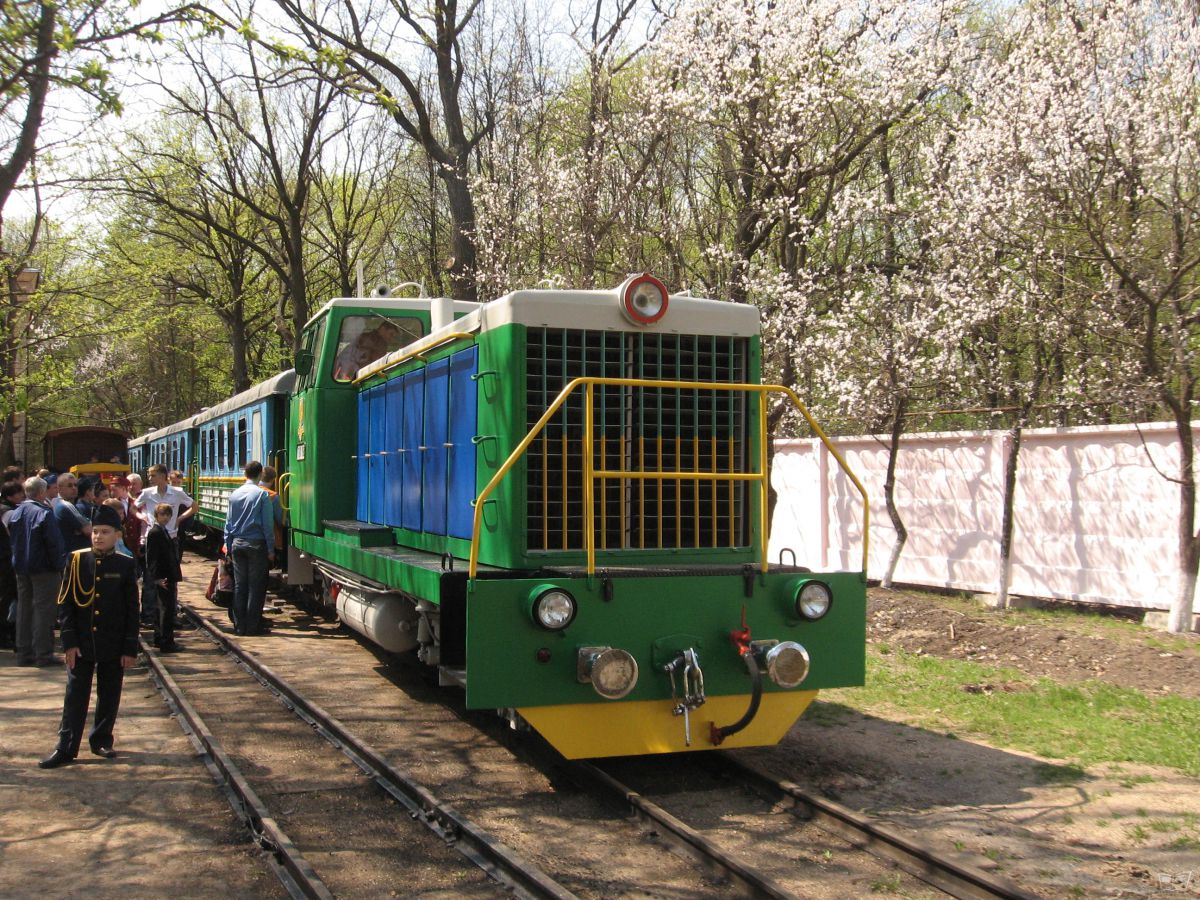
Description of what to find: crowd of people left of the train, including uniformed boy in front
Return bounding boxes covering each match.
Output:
[0,462,282,768]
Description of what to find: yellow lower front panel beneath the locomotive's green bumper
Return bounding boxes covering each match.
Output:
[517,691,817,760]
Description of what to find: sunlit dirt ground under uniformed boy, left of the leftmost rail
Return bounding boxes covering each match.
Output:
[0,650,276,900]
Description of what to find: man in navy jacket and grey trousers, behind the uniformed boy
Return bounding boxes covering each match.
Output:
[8,476,66,666]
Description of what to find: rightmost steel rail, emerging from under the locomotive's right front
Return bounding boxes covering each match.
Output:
[721,756,1037,900]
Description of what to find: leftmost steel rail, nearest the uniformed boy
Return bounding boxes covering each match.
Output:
[138,638,334,900]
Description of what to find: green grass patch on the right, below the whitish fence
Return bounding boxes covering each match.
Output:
[814,648,1200,780]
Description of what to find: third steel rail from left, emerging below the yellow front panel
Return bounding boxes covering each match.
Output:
[560,761,796,898]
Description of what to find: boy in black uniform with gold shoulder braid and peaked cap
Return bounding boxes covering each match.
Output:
[38,506,138,769]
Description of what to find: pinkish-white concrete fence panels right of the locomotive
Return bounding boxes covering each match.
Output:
[770,422,1200,611]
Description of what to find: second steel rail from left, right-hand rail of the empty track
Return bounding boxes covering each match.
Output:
[179,602,575,900]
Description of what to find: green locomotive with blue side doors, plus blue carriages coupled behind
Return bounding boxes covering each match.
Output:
[134,275,866,758]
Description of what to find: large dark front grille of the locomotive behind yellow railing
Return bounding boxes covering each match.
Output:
[524,329,749,551]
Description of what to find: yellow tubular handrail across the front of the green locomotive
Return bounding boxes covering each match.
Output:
[468,377,871,581]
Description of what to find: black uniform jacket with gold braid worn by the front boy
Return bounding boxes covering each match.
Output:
[59,550,138,662]
